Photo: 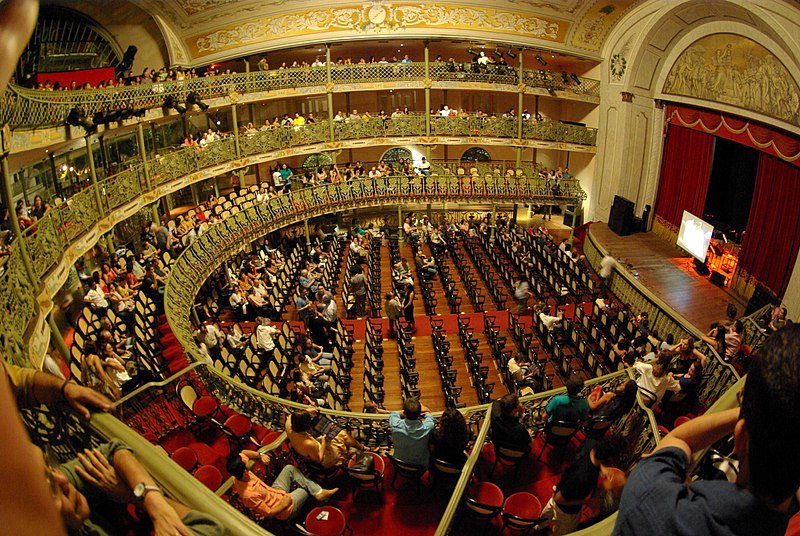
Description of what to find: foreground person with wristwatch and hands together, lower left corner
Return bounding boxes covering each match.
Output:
[46,439,226,535]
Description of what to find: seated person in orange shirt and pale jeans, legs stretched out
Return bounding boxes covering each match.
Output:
[227,450,339,520]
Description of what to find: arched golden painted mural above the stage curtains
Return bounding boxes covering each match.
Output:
[664,34,800,129]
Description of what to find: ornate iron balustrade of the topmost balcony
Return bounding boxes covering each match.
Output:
[0,62,600,129]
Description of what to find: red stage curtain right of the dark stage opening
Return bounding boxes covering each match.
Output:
[739,154,800,298]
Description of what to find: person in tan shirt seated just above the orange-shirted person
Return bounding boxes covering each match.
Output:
[286,409,364,469]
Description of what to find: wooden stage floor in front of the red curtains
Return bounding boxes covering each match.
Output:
[591,222,746,333]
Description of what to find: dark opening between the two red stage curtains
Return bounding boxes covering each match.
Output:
[703,138,760,242]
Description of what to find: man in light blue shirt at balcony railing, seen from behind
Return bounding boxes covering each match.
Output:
[378,398,436,467]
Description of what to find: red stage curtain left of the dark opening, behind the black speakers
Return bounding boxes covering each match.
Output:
[656,125,714,231]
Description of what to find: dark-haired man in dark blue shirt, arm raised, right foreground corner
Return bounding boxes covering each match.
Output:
[614,325,800,535]
